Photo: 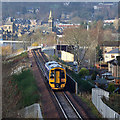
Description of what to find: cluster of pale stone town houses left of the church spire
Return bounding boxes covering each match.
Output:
[0,17,37,40]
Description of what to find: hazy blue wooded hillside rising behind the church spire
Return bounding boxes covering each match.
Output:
[2,2,118,20]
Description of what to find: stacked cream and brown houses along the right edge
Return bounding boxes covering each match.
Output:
[100,41,120,85]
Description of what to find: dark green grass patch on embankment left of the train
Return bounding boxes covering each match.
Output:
[12,70,39,107]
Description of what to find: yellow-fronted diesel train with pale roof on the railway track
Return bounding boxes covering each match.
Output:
[45,61,66,90]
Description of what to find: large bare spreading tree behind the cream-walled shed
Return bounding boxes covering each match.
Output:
[63,26,97,67]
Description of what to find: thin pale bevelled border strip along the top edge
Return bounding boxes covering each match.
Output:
[0,0,120,2]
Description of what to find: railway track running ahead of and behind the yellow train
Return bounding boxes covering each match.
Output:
[33,50,83,120]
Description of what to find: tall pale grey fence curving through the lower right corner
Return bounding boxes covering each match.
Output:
[92,88,120,120]
